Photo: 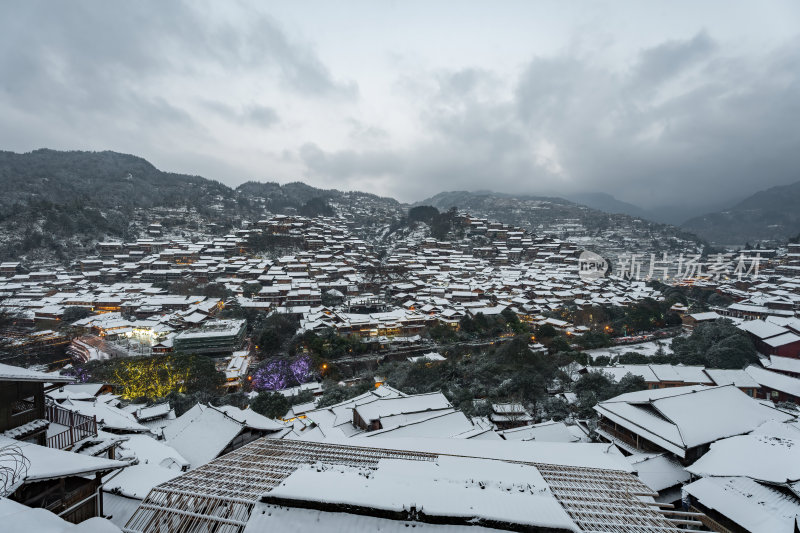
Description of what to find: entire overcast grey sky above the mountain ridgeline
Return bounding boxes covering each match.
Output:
[0,0,800,207]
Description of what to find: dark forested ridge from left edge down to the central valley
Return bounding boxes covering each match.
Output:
[0,149,400,261]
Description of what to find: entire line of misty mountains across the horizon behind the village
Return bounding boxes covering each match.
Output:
[0,149,800,256]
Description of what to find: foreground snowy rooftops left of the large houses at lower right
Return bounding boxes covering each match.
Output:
[0,365,720,532]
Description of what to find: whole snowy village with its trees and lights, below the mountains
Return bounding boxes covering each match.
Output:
[0,196,800,533]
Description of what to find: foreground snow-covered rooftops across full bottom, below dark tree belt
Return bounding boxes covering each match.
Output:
[6,342,800,533]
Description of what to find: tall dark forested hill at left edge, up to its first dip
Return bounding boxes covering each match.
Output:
[0,149,247,259]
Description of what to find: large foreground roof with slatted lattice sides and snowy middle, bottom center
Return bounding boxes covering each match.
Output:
[125,438,683,533]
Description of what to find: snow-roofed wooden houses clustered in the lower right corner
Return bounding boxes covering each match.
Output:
[595,385,800,533]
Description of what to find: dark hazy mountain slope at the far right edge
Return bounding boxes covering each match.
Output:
[681,181,800,245]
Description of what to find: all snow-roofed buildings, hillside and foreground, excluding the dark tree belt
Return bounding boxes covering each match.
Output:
[0,197,800,533]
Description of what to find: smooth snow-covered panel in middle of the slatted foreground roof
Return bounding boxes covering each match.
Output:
[266,456,579,531]
